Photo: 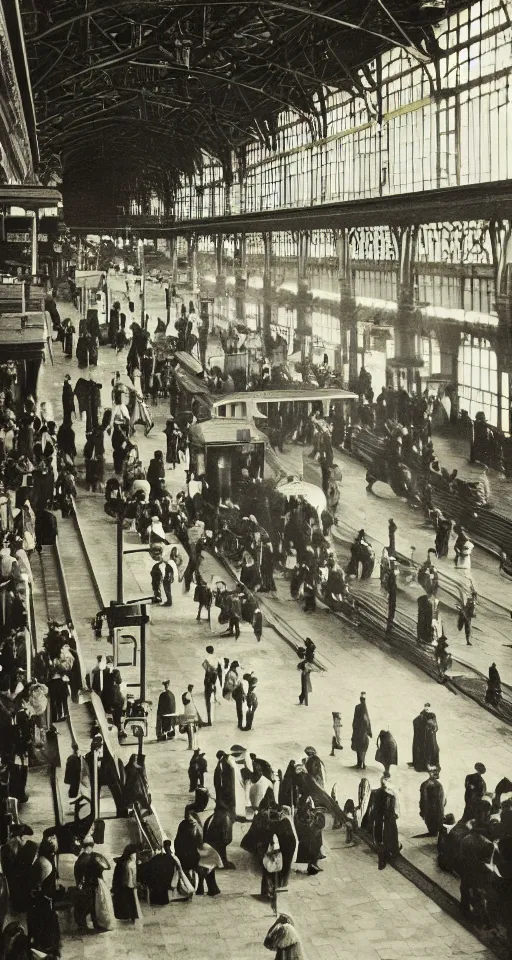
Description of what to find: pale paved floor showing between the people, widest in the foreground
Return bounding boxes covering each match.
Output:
[34,274,511,960]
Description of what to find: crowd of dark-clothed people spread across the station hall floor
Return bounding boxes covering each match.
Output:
[0,270,512,960]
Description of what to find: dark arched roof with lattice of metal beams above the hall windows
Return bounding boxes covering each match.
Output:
[20,0,469,202]
